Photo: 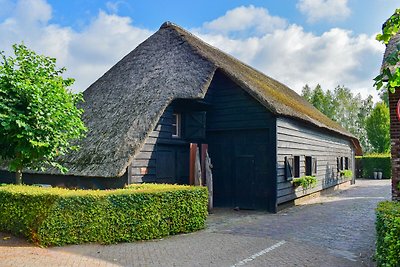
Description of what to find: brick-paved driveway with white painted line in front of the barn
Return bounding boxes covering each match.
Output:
[0,180,390,266]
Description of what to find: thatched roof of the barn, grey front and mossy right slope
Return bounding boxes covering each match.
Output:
[43,23,359,177]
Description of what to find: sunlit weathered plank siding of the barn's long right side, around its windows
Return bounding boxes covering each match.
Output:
[277,118,355,204]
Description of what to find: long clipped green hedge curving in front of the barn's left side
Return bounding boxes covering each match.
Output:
[0,184,208,246]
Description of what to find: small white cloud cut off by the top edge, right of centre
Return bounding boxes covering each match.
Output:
[297,0,351,22]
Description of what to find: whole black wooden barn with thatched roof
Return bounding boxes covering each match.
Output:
[0,22,361,212]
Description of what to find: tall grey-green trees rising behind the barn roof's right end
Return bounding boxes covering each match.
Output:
[302,85,374,152]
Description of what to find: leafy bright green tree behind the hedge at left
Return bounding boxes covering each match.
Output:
[0,44,86,184]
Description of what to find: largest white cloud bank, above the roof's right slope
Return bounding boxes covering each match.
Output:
[196,6,384,100]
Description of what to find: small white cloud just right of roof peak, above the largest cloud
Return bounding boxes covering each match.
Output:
[203,5,287,34]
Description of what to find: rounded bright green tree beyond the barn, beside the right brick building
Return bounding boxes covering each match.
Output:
[366,102,390,153]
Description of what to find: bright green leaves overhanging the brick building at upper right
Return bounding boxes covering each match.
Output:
[374,9,400,93]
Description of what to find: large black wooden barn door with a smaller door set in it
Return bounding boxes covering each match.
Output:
[207,130,275,209]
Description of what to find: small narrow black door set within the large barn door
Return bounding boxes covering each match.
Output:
[234,155,256,209]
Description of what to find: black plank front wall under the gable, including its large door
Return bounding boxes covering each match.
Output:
[204,72,276,211]
